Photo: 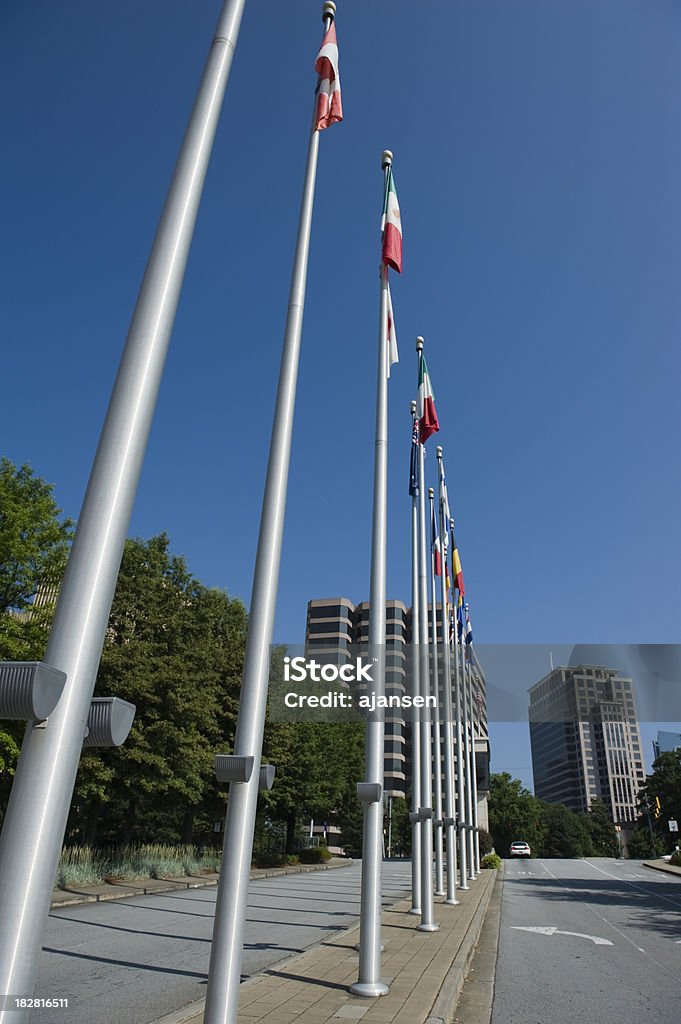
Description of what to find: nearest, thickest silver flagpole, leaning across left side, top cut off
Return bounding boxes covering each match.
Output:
[0,0,245,1024]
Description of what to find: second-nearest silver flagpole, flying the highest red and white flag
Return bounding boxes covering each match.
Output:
[204,3,336,1024]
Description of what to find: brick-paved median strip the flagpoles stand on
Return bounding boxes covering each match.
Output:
[156,870,498,1024]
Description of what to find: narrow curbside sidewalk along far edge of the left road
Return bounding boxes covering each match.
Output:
[51,857,352,910]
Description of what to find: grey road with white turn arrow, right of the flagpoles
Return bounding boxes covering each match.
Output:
[492,858,681,1024]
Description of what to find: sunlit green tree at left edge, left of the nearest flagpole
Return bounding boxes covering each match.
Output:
[0,458,72,821]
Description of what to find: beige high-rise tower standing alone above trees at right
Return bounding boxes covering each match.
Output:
[529,665,645,824]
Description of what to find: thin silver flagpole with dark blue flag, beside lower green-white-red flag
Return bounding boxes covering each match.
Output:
[410,401,421,914]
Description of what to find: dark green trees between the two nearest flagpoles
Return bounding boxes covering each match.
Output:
[70,534,247,843]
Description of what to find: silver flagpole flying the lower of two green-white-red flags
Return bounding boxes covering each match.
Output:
[416,337,439,932]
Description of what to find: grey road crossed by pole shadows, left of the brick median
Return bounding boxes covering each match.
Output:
[35,861,411,1024]
